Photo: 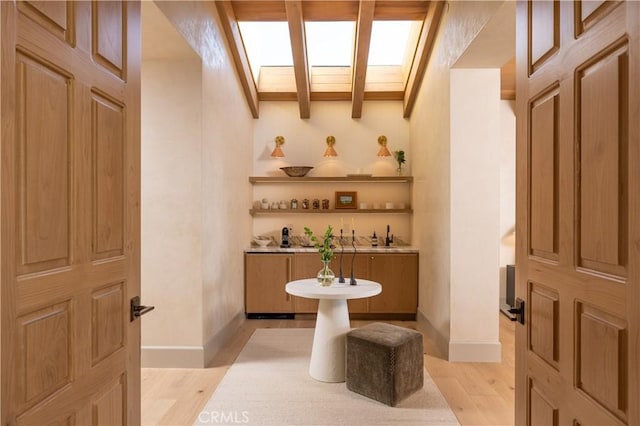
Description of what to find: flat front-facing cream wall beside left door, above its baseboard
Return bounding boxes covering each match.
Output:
[141,55,202,362]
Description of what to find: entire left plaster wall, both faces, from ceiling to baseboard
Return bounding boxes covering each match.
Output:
[142,2,254,367]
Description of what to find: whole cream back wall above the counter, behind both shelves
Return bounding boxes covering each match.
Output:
[247,101,414,243]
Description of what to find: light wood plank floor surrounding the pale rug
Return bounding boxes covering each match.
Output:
[142,315,515,426]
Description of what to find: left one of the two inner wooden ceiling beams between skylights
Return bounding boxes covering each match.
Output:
[285,0,311,118]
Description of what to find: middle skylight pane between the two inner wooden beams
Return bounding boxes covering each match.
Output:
[305,21,356,67]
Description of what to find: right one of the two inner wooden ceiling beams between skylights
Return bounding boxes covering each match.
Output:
[351,0,375,118]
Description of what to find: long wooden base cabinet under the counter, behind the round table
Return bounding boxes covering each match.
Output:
[245,253,418,316]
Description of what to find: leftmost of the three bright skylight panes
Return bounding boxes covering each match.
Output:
[238,22,293,83]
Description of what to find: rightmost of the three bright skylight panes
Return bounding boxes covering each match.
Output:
[367,21,421,65]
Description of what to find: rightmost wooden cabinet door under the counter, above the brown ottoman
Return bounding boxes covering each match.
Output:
[369,253,418,314]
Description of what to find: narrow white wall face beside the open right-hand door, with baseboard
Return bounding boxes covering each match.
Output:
[449,69,501,361]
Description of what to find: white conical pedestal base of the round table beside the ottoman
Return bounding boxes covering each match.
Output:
[309,299,351,383]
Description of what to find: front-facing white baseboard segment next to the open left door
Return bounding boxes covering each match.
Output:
[141,346,204,368]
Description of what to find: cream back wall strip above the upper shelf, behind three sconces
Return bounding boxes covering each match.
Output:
[253,101,412,176]
